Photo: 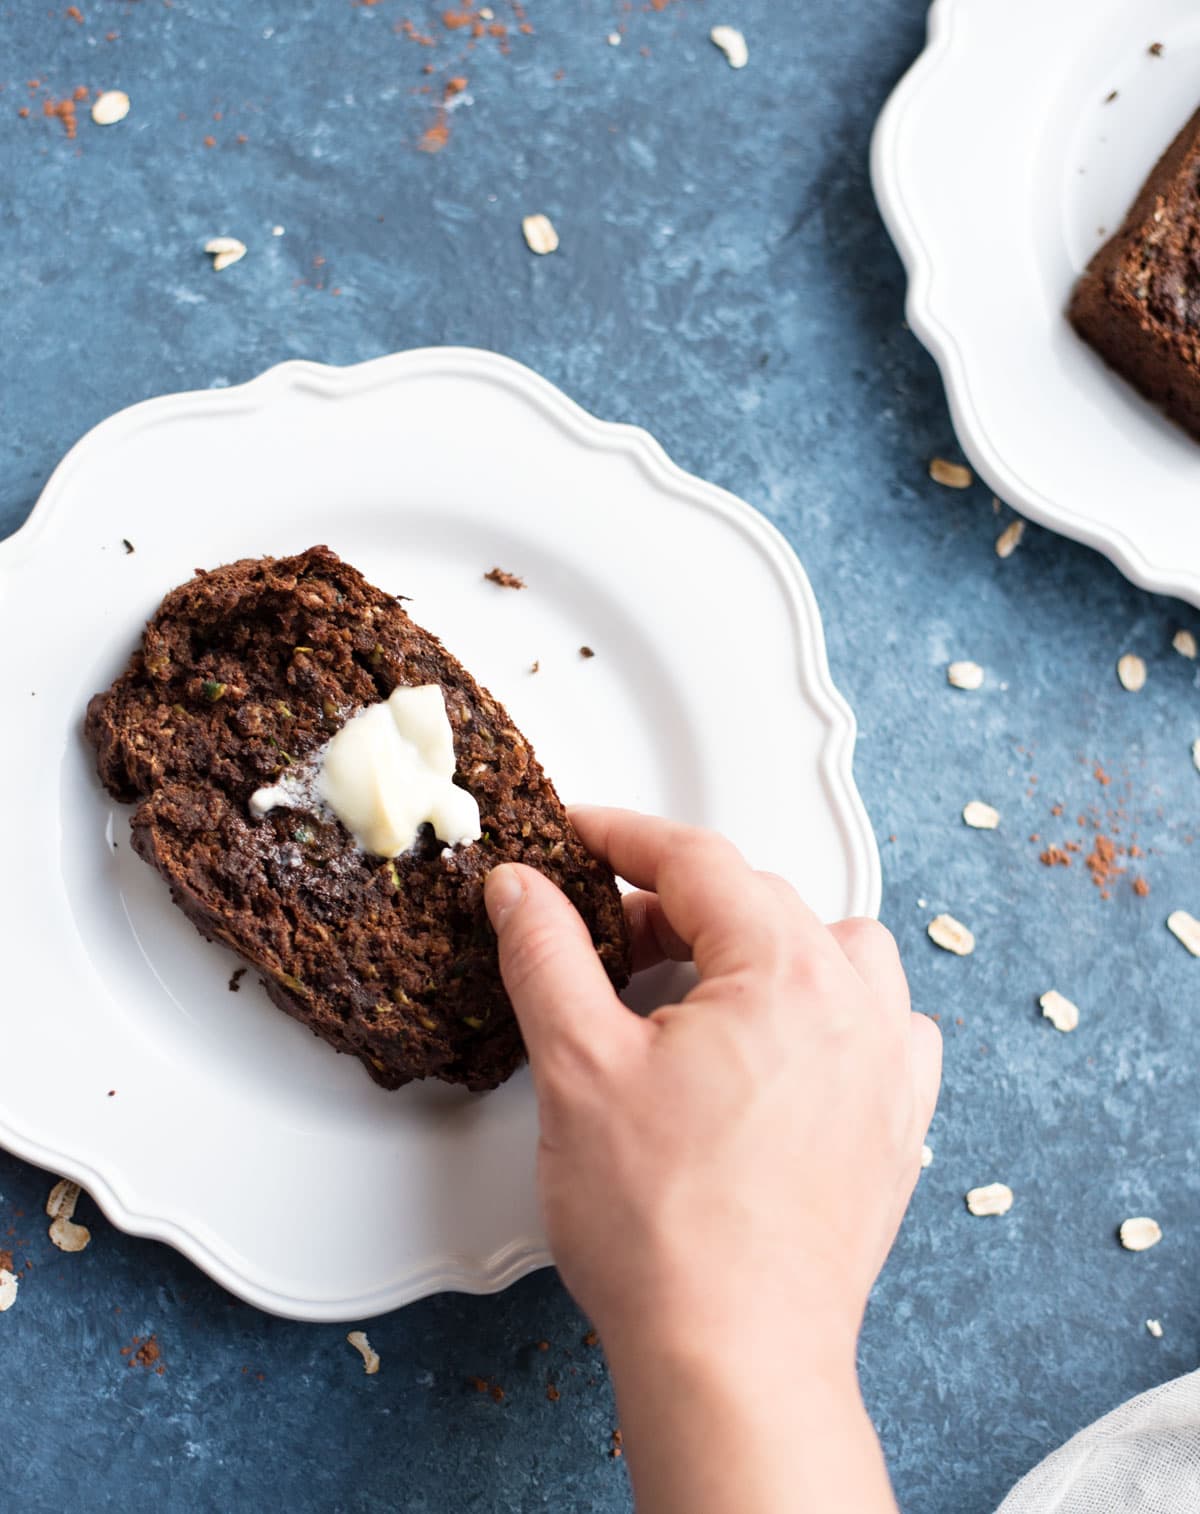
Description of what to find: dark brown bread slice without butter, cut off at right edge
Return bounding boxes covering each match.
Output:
[1068,111,1200,439]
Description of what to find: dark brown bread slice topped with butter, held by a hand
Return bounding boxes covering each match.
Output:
[86,547,628,1089]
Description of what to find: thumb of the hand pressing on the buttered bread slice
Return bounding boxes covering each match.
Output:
[484,863,637,1073]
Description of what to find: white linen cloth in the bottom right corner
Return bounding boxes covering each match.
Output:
[997,1372,1200,1514]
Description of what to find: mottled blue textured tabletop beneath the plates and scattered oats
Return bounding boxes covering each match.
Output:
[0,0,1200,1514]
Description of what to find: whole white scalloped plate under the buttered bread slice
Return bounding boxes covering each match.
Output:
[0,348,879,1320]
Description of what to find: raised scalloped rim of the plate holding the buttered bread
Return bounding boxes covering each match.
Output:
[0,347,882,1323]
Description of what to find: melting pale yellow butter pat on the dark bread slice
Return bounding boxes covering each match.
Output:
[250,683,483,857]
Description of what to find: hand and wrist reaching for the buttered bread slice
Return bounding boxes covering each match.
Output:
[486,808,941,1514]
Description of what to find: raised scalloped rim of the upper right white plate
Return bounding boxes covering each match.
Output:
[870,0,1200,607]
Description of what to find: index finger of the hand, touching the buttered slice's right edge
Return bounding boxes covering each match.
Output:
[570,808,831,977]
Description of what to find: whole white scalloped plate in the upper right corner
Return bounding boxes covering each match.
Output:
[872,0,1200,606]
